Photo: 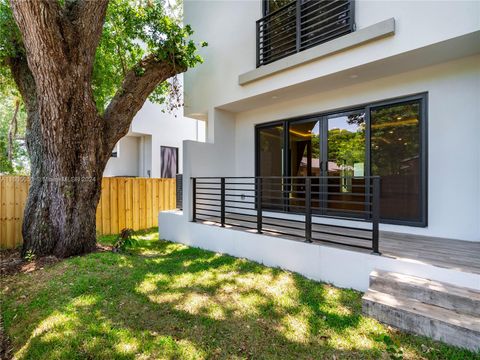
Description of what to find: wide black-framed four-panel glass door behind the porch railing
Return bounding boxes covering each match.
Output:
[256,94,427,226]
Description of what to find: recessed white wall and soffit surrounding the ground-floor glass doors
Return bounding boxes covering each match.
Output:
[231,56,480,241]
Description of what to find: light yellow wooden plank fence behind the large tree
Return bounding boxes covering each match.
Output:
[0,176,176,248]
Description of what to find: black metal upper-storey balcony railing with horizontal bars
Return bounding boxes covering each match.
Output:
[257,0,355,67]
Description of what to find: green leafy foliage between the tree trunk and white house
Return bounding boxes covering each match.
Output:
[93,0,206,112]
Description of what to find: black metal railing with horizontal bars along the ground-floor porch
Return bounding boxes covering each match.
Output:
[192,176,380,254]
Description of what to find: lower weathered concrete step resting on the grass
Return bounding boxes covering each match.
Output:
[362,290,480,351]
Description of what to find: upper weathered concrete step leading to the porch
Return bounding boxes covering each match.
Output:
[370,270,480,317]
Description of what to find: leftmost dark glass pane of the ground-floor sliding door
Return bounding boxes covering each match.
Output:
[258,125,284,209]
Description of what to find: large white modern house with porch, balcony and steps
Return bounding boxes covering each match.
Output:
[159,0,480,348]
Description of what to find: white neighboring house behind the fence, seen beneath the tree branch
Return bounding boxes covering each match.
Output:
[103,78,205,178]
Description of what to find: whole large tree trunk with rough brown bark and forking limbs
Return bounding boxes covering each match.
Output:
[9,0,185,257]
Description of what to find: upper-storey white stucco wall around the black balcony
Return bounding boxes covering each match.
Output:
[184,0,480,117]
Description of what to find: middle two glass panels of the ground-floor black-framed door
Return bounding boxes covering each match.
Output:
[288,111,366,215]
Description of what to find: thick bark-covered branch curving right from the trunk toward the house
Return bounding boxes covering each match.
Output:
[104,55,186,147]
